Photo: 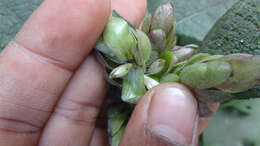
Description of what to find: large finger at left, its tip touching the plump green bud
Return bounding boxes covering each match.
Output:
[0,0,110,146]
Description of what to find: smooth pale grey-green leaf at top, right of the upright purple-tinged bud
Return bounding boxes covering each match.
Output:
[148,0,237,45]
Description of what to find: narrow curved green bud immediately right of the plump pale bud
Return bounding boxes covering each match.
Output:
[133,30,152,67]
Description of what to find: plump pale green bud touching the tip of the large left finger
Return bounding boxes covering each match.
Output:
[103,16,137,61]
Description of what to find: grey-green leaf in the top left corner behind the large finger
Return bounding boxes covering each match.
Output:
[0,0,42,51]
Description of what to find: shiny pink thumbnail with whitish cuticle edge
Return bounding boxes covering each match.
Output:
[148,85,197,146]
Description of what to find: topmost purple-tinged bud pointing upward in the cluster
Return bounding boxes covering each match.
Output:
[151,2,174,34]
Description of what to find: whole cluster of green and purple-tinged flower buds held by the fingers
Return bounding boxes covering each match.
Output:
[96,2,260,103]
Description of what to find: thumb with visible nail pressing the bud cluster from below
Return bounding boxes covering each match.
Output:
[120,83,198,146]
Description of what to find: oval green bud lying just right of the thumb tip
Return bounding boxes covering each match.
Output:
[180,61,232,89]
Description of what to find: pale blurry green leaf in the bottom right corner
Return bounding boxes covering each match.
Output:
[202,99,260,146]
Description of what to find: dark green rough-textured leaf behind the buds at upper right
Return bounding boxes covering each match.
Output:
[200,0,260,98]
